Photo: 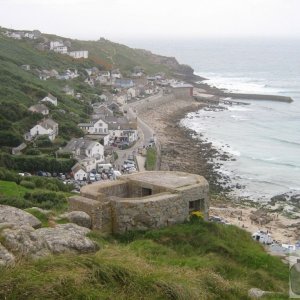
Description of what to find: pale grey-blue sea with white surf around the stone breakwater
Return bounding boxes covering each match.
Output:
[127,38,300,201]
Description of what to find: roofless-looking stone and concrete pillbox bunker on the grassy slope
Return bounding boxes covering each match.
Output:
[69,172,209,233]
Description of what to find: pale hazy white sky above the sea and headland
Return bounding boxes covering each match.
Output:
[0,0,300,41]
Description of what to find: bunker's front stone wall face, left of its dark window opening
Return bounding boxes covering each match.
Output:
[111,193,189,232]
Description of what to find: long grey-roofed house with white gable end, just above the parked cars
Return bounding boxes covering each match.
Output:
[60,138,104,162]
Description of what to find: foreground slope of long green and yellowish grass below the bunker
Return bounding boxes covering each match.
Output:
[0,221,288,300]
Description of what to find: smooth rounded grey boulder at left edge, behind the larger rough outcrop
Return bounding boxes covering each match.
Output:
[0,205,42,228]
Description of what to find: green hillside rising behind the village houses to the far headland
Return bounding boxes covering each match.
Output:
[0,27,192,151]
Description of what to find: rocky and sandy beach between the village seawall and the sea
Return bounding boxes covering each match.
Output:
[137,90,300,244]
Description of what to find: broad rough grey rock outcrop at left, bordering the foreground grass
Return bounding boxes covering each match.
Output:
[0,224,98,259]
